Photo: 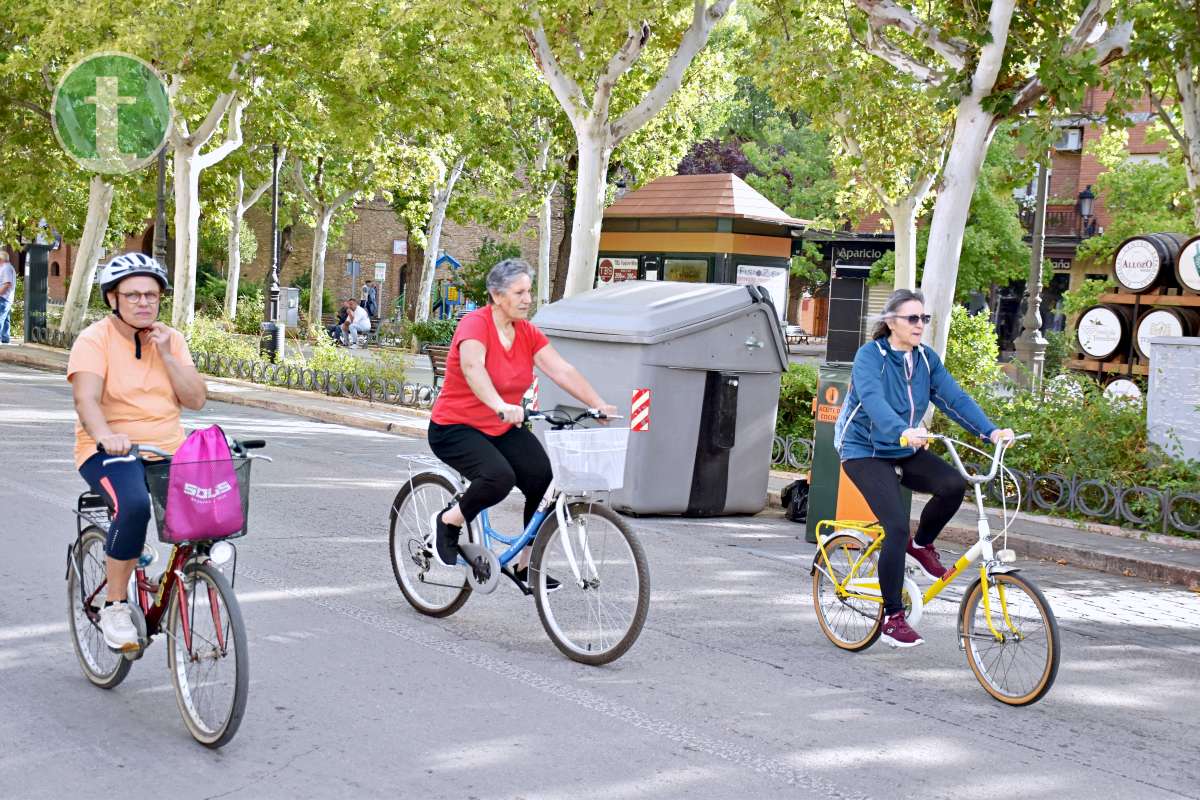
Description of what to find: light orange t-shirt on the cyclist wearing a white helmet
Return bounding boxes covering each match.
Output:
[67,317,192,469]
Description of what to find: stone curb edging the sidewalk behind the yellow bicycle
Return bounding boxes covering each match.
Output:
[767,488,1200,590]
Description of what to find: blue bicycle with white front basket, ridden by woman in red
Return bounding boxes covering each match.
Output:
[389,409,650,664]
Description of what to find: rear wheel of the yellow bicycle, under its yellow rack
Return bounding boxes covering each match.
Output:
[812,534,883,652]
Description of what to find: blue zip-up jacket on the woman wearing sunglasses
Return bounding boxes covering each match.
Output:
[833,338,998,461]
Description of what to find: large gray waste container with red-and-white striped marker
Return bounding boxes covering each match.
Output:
[534,281,787,517]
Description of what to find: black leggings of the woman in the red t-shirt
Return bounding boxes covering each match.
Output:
[430,422,553,525]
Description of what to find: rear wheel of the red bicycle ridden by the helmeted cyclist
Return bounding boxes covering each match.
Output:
[67,528,132,688]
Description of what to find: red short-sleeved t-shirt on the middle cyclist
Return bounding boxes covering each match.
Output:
[433,306,550,437]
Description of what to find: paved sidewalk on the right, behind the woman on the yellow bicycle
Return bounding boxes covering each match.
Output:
[768,471,1200,591]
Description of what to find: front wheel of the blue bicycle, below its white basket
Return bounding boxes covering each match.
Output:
[529,503,650,666]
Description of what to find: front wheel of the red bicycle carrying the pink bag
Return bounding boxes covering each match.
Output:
[167,563,250,748]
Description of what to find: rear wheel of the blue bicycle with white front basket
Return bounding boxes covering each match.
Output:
[388,473,470,616]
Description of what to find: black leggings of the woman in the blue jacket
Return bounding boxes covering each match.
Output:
[841,450,967,614]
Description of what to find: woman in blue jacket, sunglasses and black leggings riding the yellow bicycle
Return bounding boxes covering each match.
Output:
[834,289,1013,648]
